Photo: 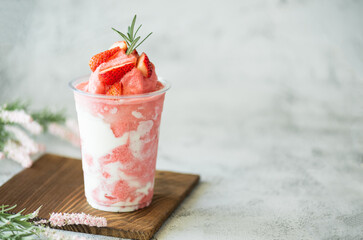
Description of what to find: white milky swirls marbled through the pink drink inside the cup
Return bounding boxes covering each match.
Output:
[77,103,157,212]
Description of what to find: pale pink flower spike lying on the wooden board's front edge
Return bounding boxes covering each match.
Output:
[49,213,107,227]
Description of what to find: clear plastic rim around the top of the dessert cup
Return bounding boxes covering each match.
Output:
[68,75,171,99]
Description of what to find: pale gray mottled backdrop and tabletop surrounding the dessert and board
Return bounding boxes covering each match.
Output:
[0,0,363,239]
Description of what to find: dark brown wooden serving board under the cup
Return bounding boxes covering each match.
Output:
[0,154,199,239]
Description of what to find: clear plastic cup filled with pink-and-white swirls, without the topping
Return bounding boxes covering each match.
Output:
[69,77,170,212]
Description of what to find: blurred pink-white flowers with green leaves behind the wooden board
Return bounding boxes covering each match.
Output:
[0,101,80,168]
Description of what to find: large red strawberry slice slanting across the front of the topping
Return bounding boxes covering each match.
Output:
[98,61,135,85]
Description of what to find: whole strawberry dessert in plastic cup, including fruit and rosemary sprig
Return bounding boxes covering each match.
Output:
[70,16,169,212]
